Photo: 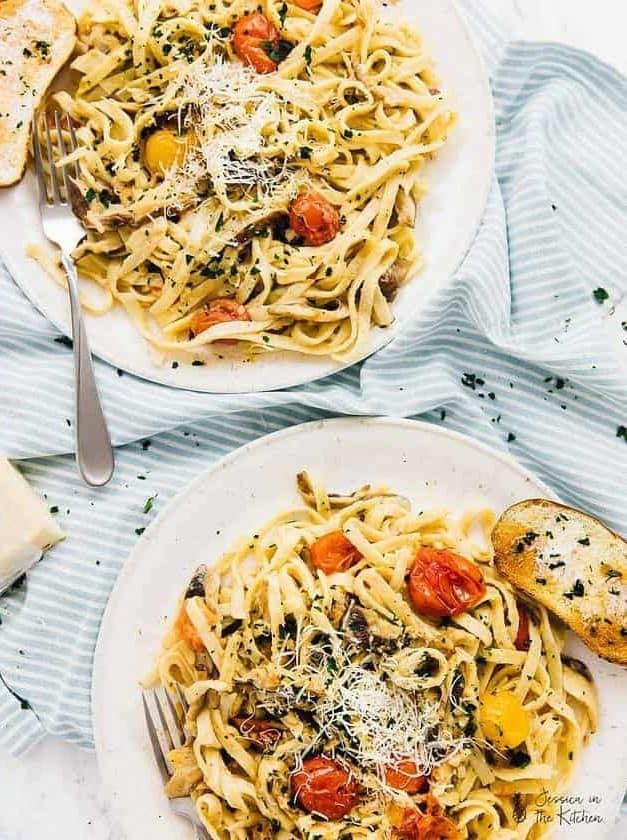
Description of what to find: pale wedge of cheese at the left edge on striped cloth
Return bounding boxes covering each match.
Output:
[0,457,64,589]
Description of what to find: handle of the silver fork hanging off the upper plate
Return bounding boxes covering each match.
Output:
[61,253,114,487]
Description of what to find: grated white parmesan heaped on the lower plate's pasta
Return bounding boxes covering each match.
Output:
[260,627,472,793]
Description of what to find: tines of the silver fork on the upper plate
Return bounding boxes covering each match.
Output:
[33,111,80,204]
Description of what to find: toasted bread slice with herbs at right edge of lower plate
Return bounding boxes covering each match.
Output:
[492,499,627,665]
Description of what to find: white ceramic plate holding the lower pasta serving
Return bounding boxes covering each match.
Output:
[92,418,627,840]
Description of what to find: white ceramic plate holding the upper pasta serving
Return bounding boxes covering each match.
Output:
[0,0,494,393]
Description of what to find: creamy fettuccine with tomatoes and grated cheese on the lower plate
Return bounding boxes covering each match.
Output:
[149,473,597,840]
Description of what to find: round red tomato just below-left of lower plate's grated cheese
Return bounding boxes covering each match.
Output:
[290,755,359,820]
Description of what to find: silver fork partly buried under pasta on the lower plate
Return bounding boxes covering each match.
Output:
[142,685,207,840]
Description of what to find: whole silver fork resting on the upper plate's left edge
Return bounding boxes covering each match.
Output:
[33,111,114,487]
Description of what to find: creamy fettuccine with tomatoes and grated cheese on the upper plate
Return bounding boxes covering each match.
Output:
[35,0,455,361]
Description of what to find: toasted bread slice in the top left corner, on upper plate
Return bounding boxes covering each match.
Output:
[0,0,76,187]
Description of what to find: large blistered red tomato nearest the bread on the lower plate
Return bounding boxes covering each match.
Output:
[408,546,486,618]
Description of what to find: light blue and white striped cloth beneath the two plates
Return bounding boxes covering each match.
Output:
[0,0,627,754]
